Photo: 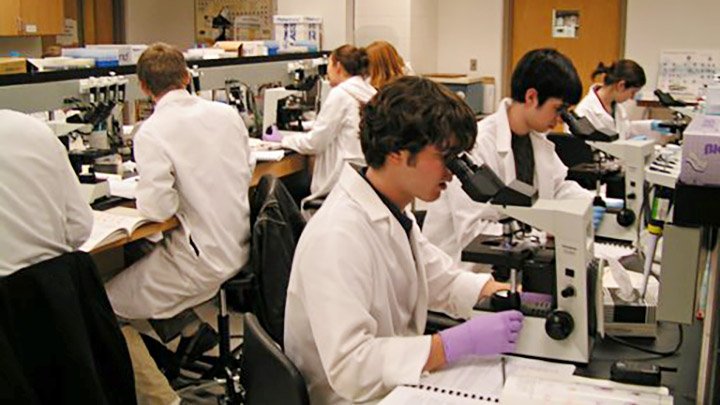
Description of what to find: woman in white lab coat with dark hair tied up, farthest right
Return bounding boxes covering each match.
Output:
[566,59,668,139]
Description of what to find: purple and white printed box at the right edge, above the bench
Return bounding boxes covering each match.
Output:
[680,114,720,186]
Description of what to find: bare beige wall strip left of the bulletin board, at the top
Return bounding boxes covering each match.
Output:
[125,0,195,49]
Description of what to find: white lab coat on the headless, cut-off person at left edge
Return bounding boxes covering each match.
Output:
[0,110,93,277]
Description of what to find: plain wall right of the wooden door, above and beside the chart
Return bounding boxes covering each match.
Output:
[625,0,720,99]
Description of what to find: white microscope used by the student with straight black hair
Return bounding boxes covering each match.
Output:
[561,110,655,245]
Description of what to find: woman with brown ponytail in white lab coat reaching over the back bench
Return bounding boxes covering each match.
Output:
[266,45,375,214]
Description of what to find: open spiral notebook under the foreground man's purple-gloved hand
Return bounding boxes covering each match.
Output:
[380,356,575,405]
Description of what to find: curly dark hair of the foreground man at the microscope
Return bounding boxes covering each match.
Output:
[360,76,477,169]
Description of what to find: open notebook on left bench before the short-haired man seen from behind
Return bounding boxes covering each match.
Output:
[80,207,152,252]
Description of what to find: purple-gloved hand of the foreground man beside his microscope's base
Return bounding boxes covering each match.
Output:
[440,310,523,363]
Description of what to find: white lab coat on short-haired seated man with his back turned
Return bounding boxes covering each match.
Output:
[107,90,253,319]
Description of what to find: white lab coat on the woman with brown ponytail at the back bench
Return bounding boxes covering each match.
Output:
[282,76,376,208]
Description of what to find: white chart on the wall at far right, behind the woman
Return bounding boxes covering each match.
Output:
[657,50,720,98]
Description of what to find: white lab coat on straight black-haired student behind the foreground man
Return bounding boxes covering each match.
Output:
[423,98,592,261]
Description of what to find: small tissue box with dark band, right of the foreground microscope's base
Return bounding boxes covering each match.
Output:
[603,283,658,338]
